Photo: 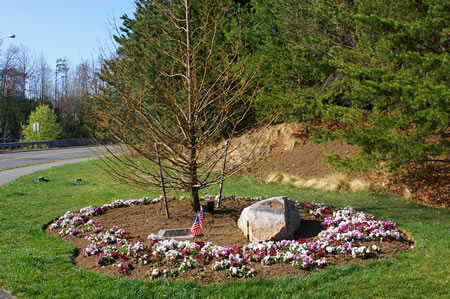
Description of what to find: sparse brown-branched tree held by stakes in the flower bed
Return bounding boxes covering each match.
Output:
[92,0,264,211]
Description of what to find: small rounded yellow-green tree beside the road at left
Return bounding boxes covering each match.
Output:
[22,105,61,141]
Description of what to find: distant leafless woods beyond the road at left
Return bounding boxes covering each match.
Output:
[0,41,102,142]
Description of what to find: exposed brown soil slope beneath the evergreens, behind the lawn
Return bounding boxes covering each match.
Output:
[245,123,450,208]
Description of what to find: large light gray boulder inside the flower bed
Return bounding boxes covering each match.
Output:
[238,196,300,242]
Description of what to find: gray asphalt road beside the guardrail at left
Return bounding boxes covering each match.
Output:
[0,146,114,171]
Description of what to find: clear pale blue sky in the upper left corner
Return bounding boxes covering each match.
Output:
[0,0,135,68]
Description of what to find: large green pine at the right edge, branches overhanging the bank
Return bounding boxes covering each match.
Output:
[325,0,450,170]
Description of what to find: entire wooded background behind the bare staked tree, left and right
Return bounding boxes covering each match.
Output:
[0,0,450,175]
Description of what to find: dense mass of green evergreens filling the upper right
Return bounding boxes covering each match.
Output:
[248,0,450,169]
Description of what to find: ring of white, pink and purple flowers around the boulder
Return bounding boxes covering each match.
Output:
[49,196,405,279]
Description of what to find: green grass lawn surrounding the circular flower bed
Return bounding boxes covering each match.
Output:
[0,161,450,298]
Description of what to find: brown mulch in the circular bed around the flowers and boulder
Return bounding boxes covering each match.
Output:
[46,200,413,284]
